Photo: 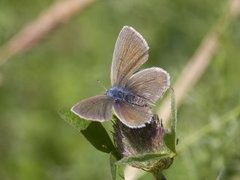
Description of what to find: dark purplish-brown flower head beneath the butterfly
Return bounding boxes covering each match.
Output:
[113,115,173,172]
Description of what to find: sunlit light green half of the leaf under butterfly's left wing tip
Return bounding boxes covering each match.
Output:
[58,108,91,131]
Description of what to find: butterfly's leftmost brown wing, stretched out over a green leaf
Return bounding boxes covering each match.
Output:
[71,95,113,122]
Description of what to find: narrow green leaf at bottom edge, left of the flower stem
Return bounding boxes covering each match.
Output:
[110,153,124,180]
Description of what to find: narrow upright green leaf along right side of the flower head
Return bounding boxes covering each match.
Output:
[164,88,177,153]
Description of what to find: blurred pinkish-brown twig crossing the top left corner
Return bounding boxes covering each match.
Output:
[0,0,94,65]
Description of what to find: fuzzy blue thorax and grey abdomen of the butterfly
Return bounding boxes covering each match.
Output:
[106,87,148,106]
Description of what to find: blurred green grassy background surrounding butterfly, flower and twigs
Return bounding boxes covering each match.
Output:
[0,0,240,180]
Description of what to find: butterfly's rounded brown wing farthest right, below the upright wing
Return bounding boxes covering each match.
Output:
[126,67,170,103]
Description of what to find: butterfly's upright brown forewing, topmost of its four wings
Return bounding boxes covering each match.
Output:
[111,26,149,86]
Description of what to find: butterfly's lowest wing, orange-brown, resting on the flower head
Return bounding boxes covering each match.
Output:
[113,101,153,128]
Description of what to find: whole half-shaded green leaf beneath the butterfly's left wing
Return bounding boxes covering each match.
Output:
[59,109,116,153]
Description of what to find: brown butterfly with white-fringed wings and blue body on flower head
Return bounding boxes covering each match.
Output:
[71,26,170,128]
